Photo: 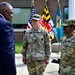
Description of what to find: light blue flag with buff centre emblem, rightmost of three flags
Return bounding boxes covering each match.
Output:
[54,2,65,42]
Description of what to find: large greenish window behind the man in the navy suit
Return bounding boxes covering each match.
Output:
[11,8,31,29]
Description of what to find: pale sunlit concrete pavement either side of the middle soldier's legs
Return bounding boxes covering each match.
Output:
[16,53,60,75]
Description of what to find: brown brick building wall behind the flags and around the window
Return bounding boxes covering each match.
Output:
[0,0,68,42]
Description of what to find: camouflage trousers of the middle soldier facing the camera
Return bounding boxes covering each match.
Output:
[26,59,46,75]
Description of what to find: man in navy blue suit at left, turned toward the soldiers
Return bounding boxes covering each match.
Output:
[0,2,16,75]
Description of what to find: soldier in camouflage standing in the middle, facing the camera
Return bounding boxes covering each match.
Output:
[22,14,50,75]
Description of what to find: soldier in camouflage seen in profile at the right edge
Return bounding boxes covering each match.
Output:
[60,20,75,75]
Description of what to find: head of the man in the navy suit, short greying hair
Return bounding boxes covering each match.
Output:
[0,2,13,20]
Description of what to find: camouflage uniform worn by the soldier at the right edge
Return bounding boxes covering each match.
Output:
[60,36,75,75]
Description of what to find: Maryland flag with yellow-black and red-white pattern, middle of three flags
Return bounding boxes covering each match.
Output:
[40,5,54,38]
